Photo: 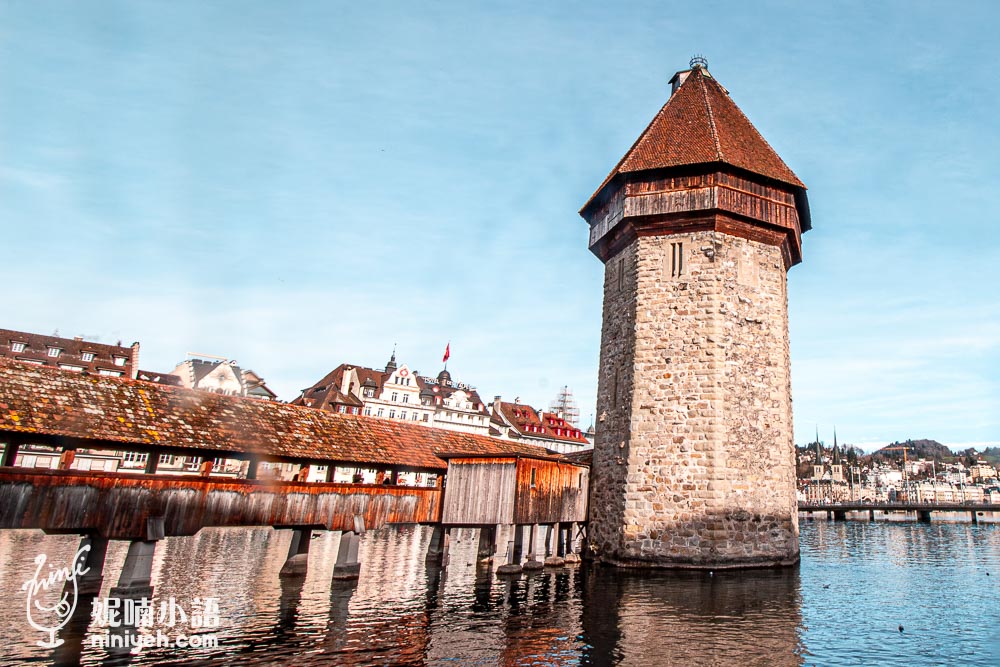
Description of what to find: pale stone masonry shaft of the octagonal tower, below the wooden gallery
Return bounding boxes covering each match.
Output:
[590,232,798,568]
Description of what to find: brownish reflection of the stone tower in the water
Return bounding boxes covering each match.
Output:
[581,568,803,667]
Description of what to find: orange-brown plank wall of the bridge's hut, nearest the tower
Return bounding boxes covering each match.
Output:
[514,458,590,524]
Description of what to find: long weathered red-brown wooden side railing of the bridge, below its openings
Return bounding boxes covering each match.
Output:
[0,468,442,540]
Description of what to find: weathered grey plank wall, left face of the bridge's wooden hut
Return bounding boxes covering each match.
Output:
[441,457,517,526]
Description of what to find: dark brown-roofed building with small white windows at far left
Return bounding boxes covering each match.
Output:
[0,329,139,378]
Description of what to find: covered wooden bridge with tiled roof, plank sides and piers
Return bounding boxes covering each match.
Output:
[0,360,589,589]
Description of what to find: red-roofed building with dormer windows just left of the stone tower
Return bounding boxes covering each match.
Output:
[490,396,592,454]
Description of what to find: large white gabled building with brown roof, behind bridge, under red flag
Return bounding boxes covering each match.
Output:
[292,351,490,435]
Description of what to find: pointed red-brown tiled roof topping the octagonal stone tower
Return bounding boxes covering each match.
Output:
[581,68,805,211]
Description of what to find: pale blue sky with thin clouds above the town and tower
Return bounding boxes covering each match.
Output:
[0,0,1000,448]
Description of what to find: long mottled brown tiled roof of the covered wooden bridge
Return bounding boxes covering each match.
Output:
[0,359,564,470]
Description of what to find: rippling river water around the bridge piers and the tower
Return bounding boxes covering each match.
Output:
[0,521,1000,667]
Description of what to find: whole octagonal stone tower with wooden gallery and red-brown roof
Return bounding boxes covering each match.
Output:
[580,58,810,569]
